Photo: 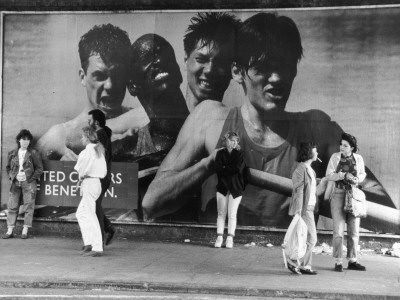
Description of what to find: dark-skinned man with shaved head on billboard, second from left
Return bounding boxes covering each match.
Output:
[128,33,189,156]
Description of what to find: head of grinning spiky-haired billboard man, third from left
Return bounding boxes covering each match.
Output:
[183,12,240,111]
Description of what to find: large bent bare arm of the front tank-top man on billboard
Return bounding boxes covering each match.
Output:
[142,101,226,217]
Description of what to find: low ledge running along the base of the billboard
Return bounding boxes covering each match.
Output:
[0,217,400,249]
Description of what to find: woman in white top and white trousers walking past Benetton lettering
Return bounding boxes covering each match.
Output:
[75,126,107,257]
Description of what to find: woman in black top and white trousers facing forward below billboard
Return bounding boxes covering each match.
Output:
[214,132,245,248]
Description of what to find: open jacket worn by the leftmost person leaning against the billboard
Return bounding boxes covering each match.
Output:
[6,149,43,183]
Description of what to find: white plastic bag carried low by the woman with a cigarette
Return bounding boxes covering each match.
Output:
[282,214,307,261]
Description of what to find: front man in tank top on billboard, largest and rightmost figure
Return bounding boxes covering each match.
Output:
[142,13,394,227]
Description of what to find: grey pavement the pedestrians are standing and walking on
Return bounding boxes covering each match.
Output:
[0,236,400,299]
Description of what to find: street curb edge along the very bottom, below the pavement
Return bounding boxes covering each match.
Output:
[0,281,399,300]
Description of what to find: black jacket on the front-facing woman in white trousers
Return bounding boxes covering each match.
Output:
[215,148,245,198]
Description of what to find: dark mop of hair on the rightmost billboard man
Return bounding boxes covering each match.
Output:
[234,13,303,71]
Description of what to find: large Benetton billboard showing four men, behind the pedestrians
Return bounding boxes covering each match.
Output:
[1,6,400,233]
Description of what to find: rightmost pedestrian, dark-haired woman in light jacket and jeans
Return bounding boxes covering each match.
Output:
[326,133,366,272]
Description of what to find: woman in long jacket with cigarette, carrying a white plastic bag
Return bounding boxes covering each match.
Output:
[288,142,318,275]
